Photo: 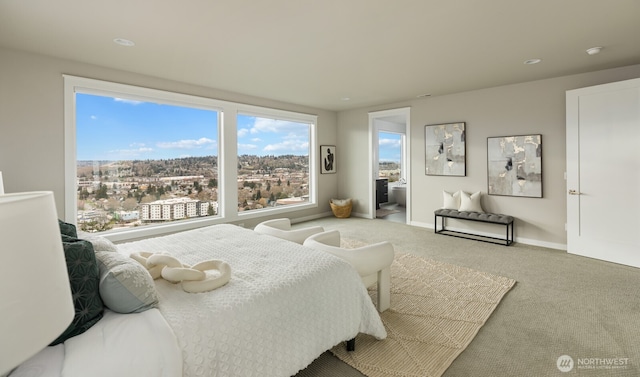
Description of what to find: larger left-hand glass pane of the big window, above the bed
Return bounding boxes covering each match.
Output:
[76,93,219,232]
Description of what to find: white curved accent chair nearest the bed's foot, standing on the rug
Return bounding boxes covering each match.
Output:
[304,230,395,312]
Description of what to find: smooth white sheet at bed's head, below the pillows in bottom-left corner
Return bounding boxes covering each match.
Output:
[10,309,182,377]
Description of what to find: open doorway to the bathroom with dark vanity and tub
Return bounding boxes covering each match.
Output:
[369,108,411,223]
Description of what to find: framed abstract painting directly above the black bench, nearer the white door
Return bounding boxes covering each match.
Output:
[487,135,542,198]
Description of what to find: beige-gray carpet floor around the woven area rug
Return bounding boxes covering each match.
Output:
[294,217,640,377]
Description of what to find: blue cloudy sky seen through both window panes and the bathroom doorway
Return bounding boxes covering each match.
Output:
[76,93,399,161]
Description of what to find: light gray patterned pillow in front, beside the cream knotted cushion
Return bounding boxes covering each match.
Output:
[96,251,158,313]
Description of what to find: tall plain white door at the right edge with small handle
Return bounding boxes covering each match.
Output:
[567,79,640,267]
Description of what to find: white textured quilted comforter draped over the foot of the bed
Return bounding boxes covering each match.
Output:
[118,225,386,377]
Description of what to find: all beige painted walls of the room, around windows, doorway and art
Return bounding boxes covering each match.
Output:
[0,44,640,248]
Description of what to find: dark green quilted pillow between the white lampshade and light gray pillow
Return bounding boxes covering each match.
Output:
[50,234,104,346]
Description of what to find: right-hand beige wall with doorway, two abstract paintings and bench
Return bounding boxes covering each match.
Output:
[338,65,640,249]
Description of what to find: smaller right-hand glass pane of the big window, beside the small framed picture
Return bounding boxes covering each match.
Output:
[237,114,311,212]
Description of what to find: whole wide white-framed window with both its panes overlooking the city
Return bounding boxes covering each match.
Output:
[64,76,317,241]
